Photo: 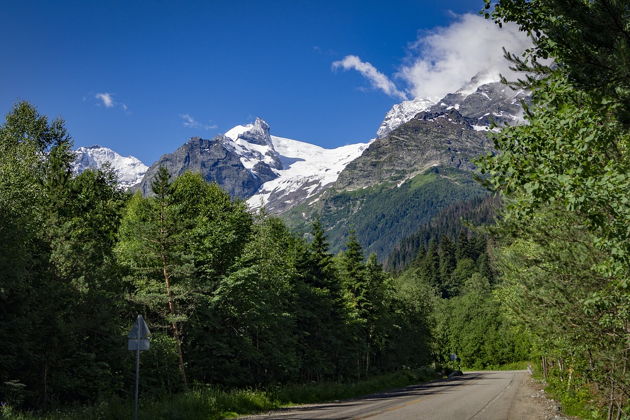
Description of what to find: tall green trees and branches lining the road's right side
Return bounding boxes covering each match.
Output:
[481,0,630,418]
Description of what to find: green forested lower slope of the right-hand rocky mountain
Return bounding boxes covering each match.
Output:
[283,167,487,260]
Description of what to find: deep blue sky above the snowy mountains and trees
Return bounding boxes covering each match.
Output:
[0,0,528,164]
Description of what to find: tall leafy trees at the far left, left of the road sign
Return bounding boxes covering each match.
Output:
[0,103,130,406]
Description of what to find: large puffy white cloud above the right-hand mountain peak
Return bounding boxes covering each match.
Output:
[396,14,531,98]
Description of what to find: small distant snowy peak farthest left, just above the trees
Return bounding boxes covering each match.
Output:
[72,145,148,189]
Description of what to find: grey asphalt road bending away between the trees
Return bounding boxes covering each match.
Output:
[245,371,536,420]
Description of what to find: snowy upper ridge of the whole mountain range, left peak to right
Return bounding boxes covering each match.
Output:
[74,74,529,214]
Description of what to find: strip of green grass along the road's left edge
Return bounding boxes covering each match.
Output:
[0,368,437,420]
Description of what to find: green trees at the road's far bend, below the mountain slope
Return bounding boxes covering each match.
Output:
[398,228,531,369]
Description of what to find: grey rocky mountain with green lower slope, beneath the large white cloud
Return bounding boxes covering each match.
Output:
[283,77,528,261]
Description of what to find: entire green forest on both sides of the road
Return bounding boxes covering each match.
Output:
[0,0,630,419]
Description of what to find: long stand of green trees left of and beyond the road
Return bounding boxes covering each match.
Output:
[0,103,527,416]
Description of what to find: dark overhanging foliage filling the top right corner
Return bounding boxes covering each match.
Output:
[484,0,630,125]
